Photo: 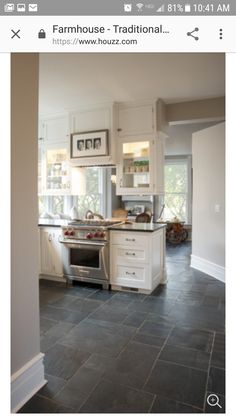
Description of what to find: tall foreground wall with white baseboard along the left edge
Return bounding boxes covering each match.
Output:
[11,54,44,411]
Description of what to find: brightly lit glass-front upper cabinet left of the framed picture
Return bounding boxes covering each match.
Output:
[41,143,71,195]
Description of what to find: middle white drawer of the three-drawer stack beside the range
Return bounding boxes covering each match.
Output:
[112,245,150,264]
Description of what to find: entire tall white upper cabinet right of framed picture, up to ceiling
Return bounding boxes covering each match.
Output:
[116,100,166,195]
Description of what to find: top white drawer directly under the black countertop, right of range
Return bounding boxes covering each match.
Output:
[111,232,149,249]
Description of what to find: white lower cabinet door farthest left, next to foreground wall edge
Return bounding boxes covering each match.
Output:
[40,229,54,275]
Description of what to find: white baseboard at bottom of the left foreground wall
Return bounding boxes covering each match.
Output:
[11,353,47,413]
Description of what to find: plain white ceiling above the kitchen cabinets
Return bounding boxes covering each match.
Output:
[39,53,225,116]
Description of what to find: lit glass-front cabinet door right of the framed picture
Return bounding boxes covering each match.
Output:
[117,140,154,195]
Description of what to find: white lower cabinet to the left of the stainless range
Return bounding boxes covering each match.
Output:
[40,227,63,281]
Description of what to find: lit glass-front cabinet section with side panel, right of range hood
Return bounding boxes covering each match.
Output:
[116,134,164,195]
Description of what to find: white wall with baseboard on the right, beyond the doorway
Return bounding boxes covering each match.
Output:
[191,123,225,280]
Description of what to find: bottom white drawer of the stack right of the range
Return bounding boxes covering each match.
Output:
[111,265,150,289]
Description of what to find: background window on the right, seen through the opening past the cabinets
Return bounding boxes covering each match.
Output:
[163,157,191,223]
